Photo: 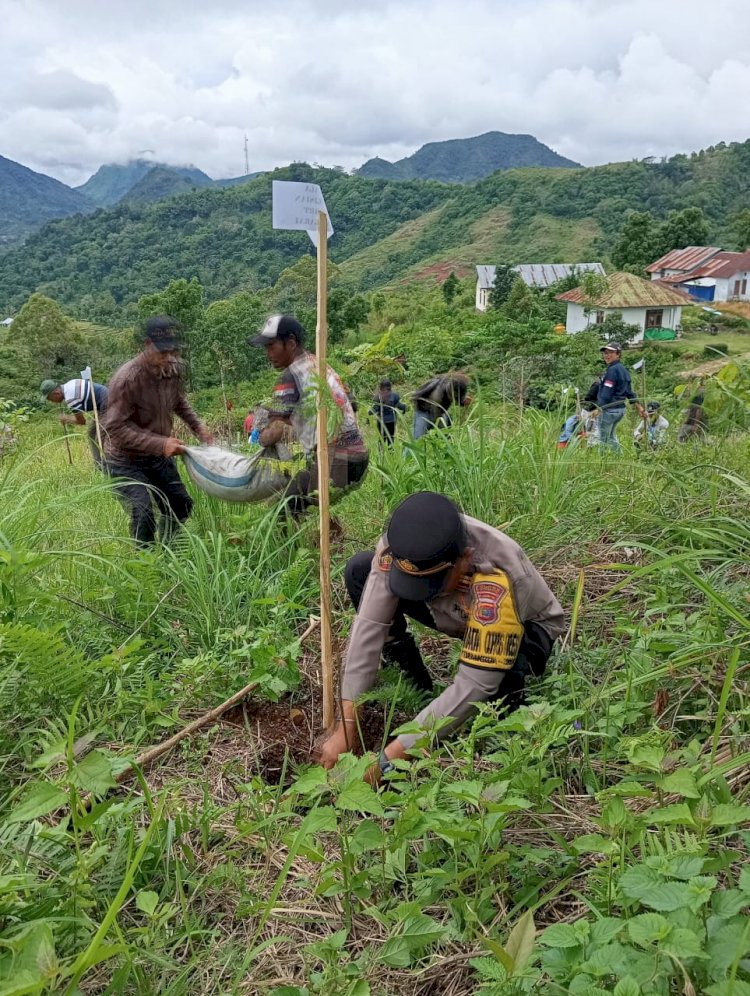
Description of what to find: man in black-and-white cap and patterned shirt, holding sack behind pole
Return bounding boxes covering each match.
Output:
[248,315,369,516]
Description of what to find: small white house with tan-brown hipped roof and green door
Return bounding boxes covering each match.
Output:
[557,273,690,342]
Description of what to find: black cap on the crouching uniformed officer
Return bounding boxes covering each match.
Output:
[386,491,466,602]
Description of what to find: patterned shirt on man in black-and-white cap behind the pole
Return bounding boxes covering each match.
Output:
[273,350,367,459]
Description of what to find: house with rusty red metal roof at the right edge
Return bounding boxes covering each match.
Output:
[646,246,750,302]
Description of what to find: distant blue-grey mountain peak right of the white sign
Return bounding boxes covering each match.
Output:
[357,131,580,183]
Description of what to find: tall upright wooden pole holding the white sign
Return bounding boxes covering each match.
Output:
[315,211,335,729]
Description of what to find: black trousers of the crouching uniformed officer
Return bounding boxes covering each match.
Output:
[344,550,554,708]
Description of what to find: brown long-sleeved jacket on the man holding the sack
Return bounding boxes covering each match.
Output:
[102,353,203,462]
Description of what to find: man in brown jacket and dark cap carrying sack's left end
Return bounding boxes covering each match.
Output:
[102,315,213,545]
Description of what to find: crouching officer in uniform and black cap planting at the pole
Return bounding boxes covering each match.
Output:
[321,491,565,772]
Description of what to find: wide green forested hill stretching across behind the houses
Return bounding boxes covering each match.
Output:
[0,141,750,311]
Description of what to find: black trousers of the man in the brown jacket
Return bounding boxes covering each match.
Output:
[107,456,193,546]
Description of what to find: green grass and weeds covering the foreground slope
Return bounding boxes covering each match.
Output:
[0,404,750,996]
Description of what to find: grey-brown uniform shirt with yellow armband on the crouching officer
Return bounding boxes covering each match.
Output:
[341,516,565,749]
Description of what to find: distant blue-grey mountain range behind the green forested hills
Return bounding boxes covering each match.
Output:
[0,132,576,251]
